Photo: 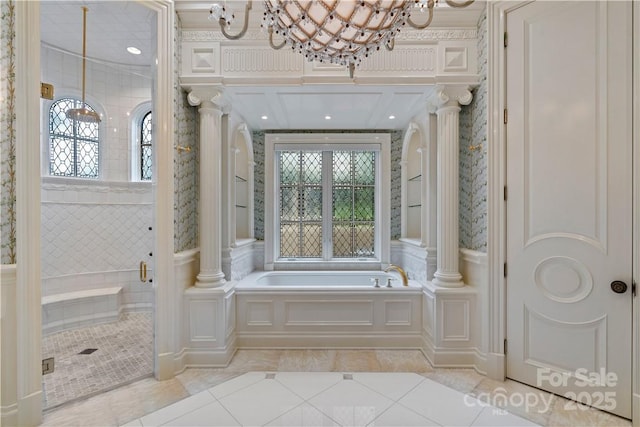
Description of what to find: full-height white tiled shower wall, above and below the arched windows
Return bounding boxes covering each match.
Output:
[41,41,153,300]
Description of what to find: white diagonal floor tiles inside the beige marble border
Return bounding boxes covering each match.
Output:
[122,372,536,427]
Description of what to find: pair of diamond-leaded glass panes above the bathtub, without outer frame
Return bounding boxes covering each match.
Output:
[277,150,376,260]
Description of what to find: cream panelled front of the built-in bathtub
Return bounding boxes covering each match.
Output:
[236,284,422,348]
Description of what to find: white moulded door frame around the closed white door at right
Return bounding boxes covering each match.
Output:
[486,1,640,426]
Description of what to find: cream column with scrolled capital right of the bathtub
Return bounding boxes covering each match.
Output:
[430,86,472,288]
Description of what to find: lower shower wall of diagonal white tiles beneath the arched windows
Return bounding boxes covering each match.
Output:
[42,179,153,280]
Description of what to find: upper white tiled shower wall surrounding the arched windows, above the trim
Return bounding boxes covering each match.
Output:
[41,45,151,181]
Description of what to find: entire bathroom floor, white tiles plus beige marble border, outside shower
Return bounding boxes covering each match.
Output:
[42,350,631,427]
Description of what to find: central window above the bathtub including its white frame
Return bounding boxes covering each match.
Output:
[265,134,389,265]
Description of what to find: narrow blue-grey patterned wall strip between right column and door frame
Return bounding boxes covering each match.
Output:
[459,12,488,252]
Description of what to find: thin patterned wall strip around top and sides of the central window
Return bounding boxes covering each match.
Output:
[252,130,402,240]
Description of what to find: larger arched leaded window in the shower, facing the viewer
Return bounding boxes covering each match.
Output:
[49,98,100,178]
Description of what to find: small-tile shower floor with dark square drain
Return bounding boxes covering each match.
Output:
[42,312,153,409]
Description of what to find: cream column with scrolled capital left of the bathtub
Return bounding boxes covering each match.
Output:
[188,88,226,288]
